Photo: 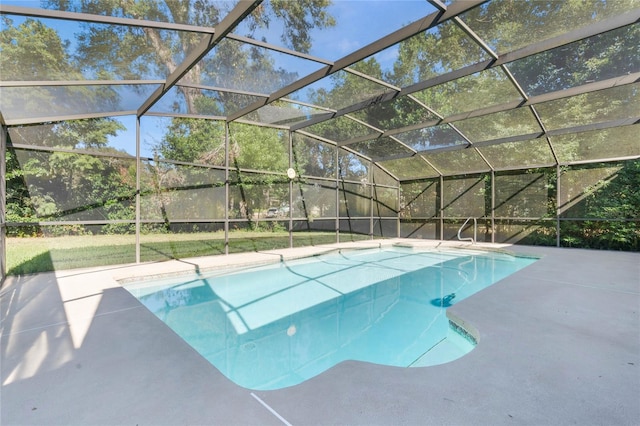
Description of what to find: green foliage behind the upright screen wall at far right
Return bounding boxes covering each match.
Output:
[401,160,640,251]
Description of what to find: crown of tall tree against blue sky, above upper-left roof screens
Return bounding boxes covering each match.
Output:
[47,0,335,113]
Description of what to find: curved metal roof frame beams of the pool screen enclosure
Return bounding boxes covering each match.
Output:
[0,0,640,181]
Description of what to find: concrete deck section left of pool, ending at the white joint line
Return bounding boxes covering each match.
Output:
[0,273,277,425]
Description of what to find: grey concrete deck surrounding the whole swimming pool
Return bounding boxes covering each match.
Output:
[0,240,640,426]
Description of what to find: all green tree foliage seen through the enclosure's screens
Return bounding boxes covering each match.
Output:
[0,0,640,256]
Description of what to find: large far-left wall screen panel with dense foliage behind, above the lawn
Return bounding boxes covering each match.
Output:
[7,149,136,221]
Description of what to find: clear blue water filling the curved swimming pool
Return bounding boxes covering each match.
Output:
[125,247,536,390]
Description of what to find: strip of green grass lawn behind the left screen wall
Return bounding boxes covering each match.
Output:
[7,231,369,275]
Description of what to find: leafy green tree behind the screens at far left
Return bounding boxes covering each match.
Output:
[0,16,135,233]
